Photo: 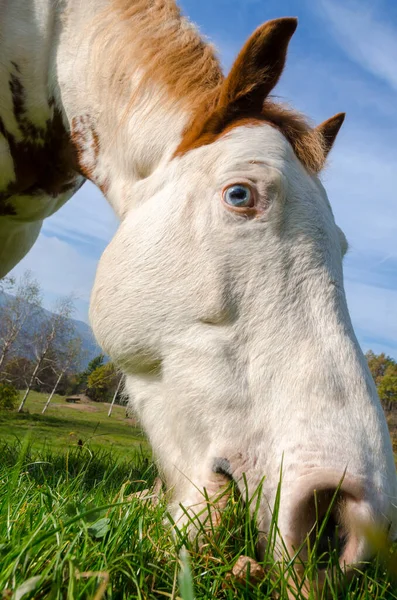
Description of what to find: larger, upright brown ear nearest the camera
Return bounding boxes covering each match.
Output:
[220,17,298,113]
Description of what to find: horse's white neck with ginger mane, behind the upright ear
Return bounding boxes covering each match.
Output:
[57,0,222,216]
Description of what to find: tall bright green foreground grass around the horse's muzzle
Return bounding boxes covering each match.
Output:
[0,443,397,600]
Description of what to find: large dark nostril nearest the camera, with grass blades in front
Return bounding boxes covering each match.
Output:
[280,470,386,598]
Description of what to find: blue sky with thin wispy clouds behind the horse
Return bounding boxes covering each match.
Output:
[10,0,397,359]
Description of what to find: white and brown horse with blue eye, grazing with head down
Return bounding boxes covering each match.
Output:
[0,0,397,592]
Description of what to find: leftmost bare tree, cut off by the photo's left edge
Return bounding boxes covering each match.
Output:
[0,271,41,370]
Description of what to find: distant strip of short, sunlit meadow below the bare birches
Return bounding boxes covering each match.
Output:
[0,392,148,455]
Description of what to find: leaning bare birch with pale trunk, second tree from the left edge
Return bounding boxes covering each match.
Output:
[18,296,74,412]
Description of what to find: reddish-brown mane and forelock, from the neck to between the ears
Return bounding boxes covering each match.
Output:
[93,0,326,172]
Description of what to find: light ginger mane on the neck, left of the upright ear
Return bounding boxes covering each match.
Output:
[95,0,223,111]
